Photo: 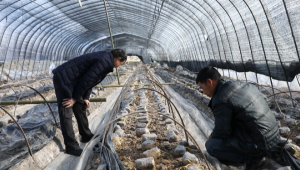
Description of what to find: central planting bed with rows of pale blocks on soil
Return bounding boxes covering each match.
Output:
[85,81,207,170]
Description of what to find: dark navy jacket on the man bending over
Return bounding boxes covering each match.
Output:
[52,51,114,101]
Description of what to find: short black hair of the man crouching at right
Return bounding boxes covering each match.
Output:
[196,66,221,84]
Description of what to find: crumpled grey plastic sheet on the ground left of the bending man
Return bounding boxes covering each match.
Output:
[0,104,59,170]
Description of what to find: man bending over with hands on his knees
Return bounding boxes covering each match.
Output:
[52,49,127,156]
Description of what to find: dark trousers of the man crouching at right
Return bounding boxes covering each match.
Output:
[205,138,270,164]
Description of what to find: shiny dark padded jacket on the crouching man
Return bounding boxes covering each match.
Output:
[209,80,280,154]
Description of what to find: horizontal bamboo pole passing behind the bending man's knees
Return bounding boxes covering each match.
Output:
[0,98,106,105]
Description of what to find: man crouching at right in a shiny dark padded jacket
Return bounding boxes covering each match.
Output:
[196,67,280,170]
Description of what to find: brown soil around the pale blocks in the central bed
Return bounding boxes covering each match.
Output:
[86,83,207,170]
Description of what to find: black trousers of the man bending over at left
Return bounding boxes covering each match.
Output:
[53,76,93,150]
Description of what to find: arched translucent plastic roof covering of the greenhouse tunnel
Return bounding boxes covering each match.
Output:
[0,0,300,81]
